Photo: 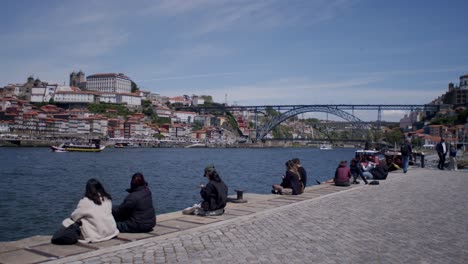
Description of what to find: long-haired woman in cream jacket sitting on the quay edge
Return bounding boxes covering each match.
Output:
[51,179,119,245]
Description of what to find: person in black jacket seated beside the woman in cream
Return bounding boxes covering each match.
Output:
[112,172,156,233]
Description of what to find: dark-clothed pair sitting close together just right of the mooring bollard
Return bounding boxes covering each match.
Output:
[271,158,307,195]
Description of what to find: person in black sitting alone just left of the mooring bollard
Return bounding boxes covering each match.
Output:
[182,165,228,216]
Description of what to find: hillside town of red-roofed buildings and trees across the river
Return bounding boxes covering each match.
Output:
[0,70,468,147]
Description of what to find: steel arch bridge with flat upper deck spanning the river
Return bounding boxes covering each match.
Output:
[176,104,439,140]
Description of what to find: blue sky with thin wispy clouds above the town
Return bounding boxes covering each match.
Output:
[0,0,468,121]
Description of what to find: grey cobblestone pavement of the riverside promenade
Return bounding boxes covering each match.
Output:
[47,169,468,263]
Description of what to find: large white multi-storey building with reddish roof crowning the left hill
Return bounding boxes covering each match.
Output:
[86,73,132,93]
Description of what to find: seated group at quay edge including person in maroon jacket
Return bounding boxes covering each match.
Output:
[329,158,388,187]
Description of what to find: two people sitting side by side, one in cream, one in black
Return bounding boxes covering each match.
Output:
[52,172,156,244]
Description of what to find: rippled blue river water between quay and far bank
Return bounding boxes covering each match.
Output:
[0,147,354,241]
